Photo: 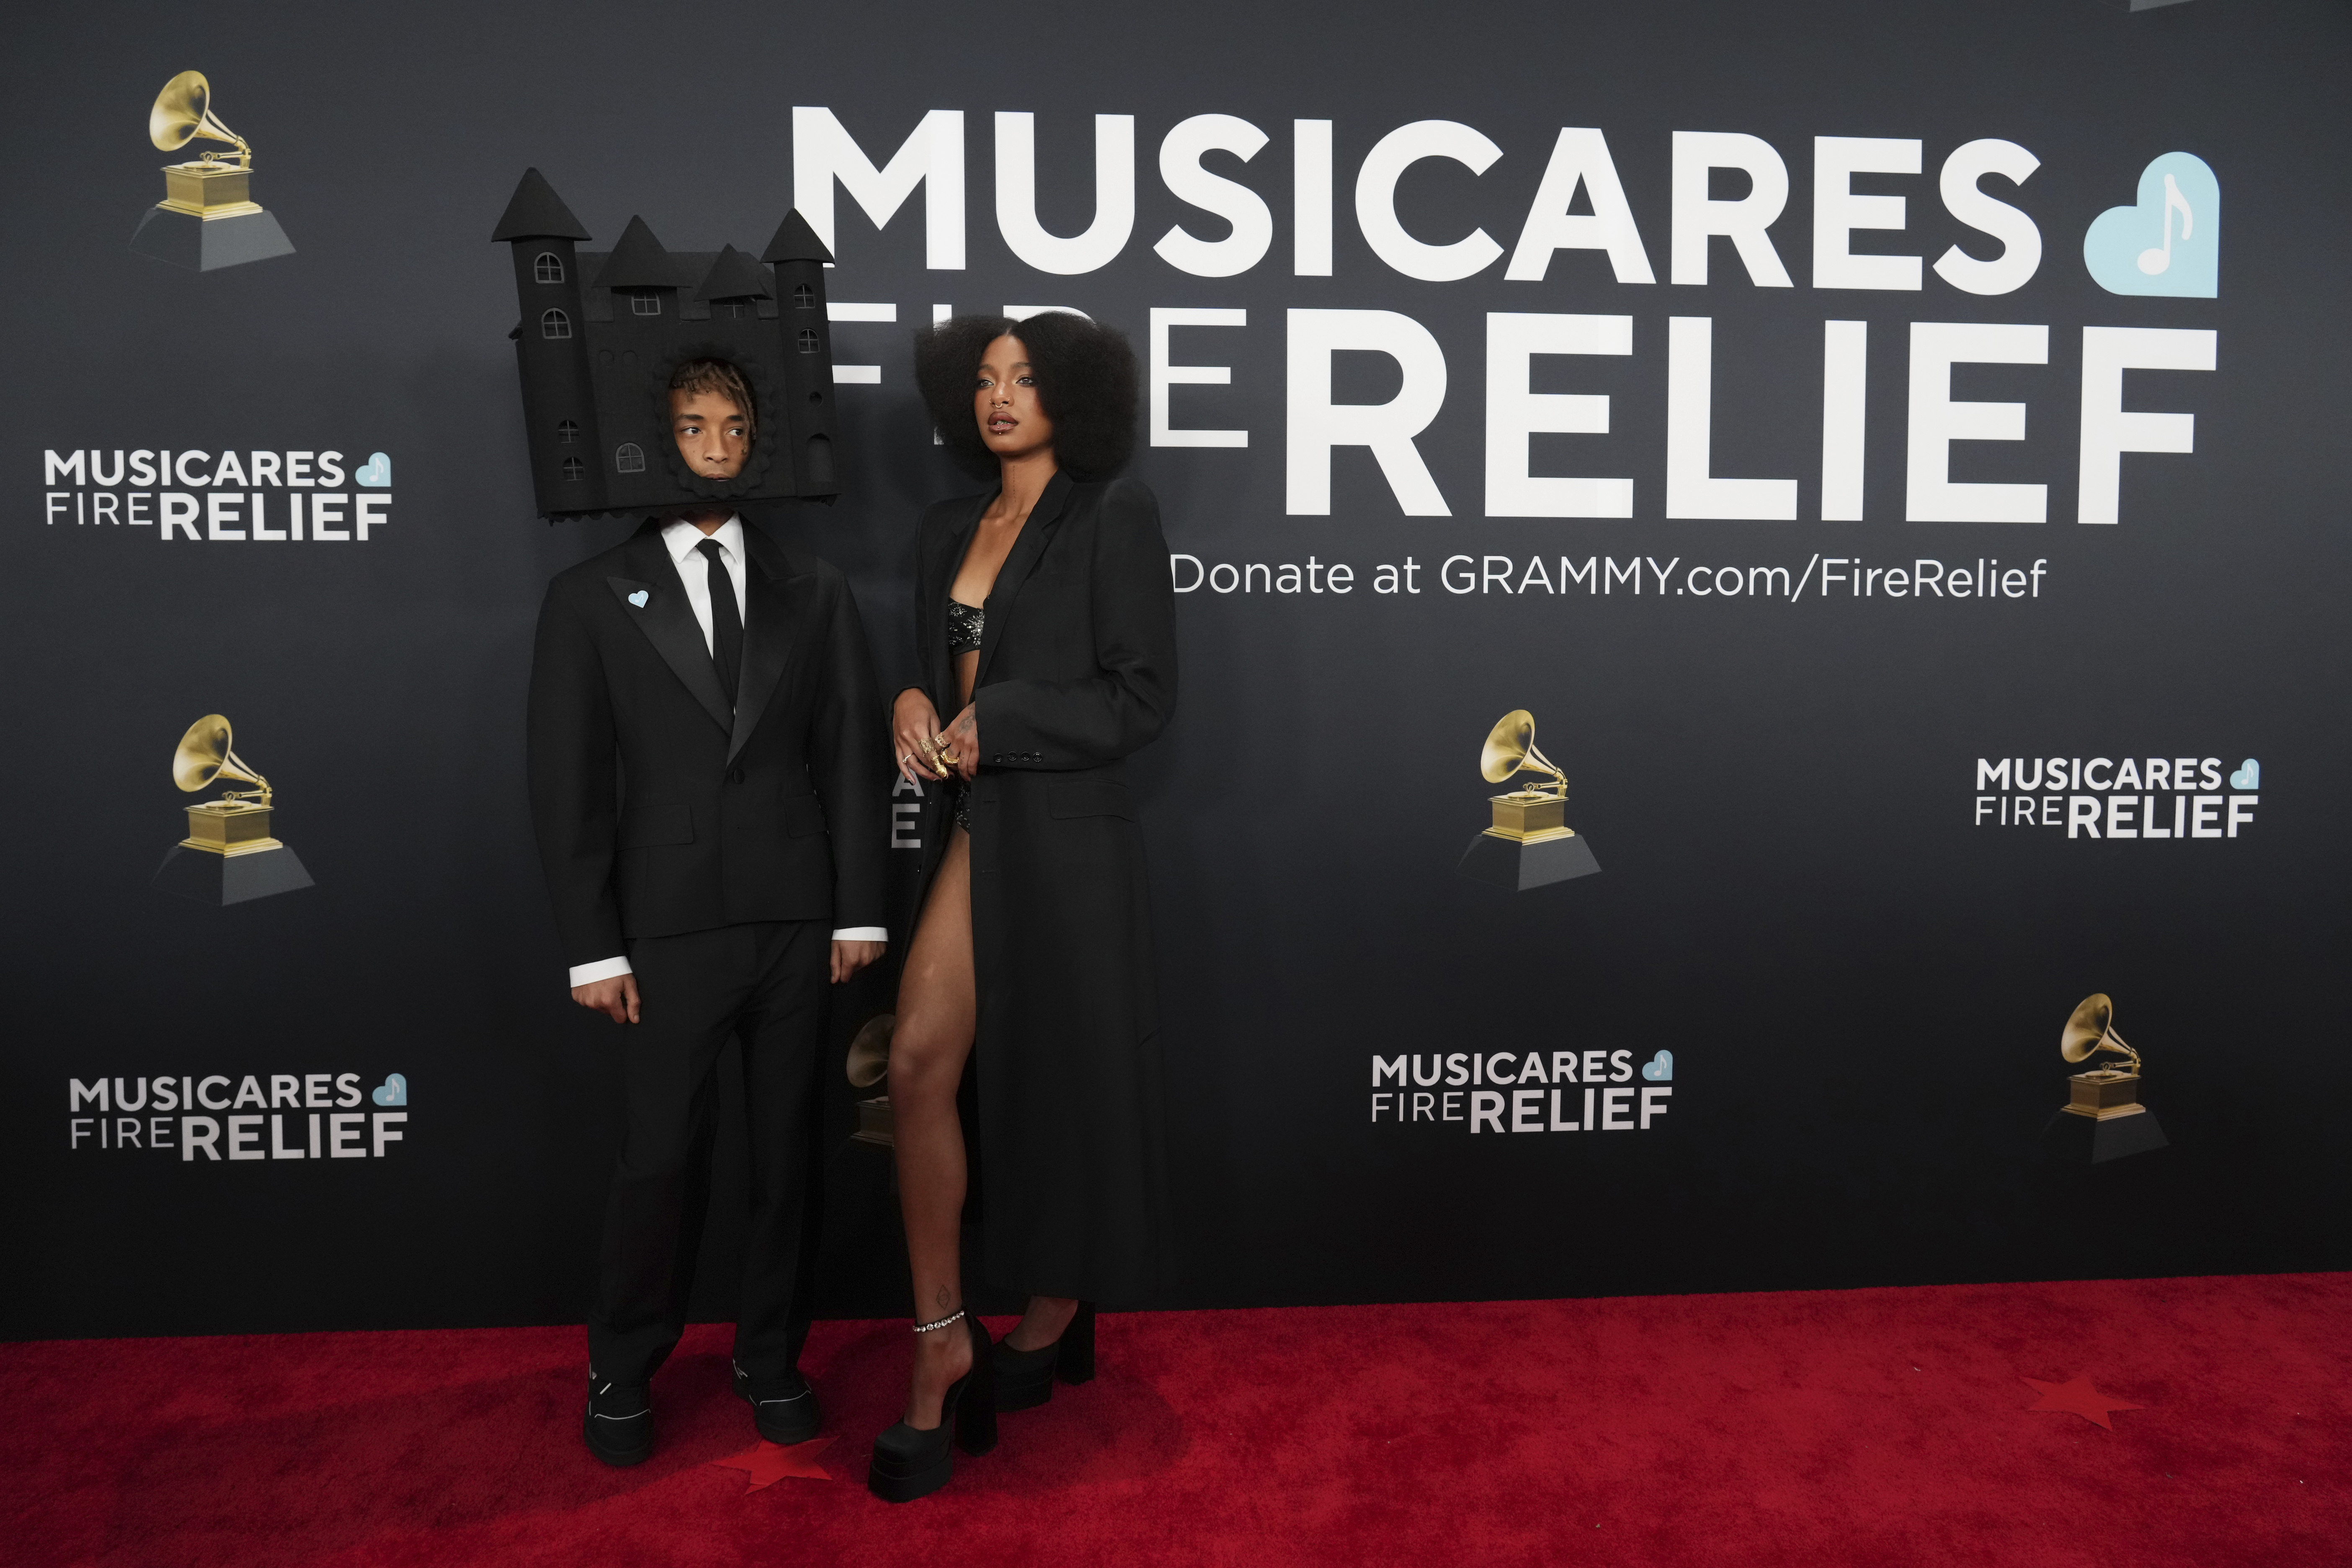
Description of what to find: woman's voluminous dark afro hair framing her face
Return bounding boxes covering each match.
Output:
[915,310,1136,480]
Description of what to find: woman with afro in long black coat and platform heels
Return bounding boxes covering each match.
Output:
[868,313,1176,1502]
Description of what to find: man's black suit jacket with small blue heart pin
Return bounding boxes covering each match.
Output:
[529,522,889,964]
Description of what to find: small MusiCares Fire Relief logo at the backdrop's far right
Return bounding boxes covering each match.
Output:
[1975,757,2263,839]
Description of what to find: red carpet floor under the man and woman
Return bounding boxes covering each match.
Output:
[0,1274,2352,1568]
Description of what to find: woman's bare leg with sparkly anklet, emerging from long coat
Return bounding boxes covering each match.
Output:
[889,828,978,1431]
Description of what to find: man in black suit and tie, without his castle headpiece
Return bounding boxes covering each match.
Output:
[529,360,889,1465]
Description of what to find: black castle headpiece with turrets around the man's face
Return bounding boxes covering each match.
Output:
[489,169,840,520]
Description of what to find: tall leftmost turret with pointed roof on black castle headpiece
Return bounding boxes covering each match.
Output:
[489,169,604,517]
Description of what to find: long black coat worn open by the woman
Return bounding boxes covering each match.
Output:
[908,475,1176,1302]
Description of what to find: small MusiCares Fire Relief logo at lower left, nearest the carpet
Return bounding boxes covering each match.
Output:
[66,1072,409,1164]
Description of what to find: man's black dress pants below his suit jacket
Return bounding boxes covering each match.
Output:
[588,919,833,1385]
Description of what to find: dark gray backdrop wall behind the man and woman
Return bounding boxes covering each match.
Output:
[0,0,2352,1335]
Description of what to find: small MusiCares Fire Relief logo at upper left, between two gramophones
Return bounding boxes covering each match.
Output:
[40,447,393,545]
